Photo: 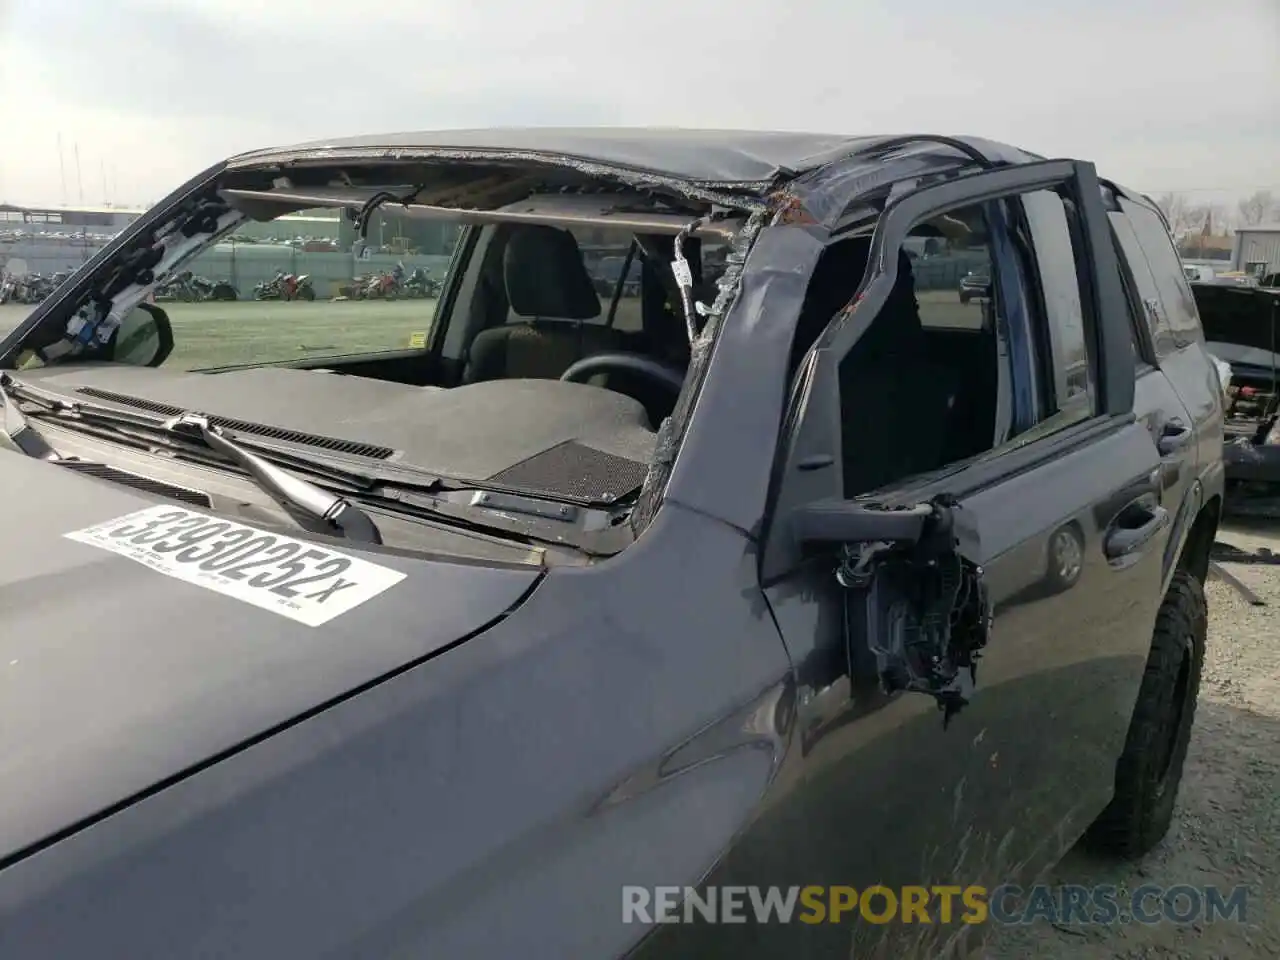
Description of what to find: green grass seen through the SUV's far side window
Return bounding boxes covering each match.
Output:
[0,300,435,370]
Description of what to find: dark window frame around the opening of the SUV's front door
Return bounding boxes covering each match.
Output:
[760,160,1133,582]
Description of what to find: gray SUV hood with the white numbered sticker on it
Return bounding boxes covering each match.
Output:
[0,451,540,860]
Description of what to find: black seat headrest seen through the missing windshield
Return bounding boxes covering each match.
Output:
[502,225,600,320]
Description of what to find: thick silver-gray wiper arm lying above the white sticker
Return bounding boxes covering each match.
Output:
[163,413,383,544]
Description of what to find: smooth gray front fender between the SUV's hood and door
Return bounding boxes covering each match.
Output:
[0,504,795,960]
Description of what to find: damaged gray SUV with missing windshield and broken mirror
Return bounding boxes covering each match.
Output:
[0,129,1224,960]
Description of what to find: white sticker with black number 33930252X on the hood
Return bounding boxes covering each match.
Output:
[64,507,404,627]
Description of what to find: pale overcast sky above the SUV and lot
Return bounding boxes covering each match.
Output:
[0,0,1280,204]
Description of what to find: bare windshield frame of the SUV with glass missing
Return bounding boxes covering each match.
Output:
[0,157,768,549]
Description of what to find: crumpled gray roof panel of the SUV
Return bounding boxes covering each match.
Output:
[228,127,1037,195]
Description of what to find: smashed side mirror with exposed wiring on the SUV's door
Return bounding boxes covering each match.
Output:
[794,497,992,727]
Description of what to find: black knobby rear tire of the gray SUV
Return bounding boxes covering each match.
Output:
[1084,570,1208,858]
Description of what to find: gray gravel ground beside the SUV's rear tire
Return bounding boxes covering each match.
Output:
[979,522,1280,960]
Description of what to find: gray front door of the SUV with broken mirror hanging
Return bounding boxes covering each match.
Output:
[759,161,1169,956]
